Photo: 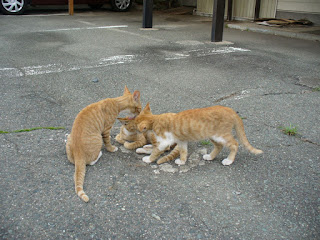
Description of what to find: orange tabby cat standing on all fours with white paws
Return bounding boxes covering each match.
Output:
[135,103,263,165]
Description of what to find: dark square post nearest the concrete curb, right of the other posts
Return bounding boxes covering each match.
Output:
[211,0,225,42]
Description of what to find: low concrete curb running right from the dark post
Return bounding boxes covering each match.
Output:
[227,24,320,41]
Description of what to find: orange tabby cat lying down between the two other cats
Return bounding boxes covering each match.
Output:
[116,118,179,162]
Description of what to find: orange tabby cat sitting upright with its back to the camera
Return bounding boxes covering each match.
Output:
[66,87,141,202]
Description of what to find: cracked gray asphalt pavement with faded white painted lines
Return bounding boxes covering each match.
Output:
[0,5,320,239]
